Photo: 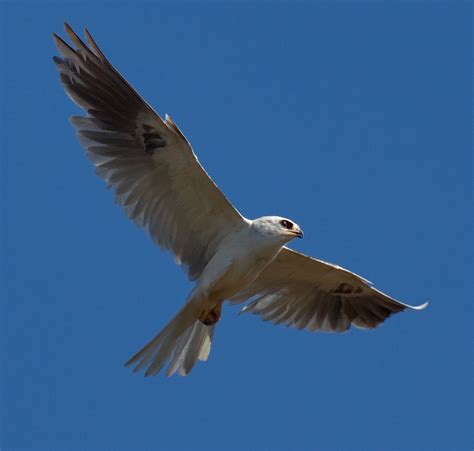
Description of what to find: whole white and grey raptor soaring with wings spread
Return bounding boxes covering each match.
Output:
[53,23,428,376]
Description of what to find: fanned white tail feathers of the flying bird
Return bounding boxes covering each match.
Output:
[125,300,215,376]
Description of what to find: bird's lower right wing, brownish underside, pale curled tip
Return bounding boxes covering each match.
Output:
[231,247,427,332]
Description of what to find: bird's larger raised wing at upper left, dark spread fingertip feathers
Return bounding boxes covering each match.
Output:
[54,24,244,280]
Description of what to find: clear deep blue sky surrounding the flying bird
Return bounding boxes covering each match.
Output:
[0,1,473,450]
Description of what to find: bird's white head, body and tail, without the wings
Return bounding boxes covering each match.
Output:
[127,216,302,375]
